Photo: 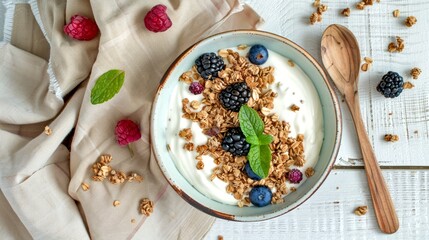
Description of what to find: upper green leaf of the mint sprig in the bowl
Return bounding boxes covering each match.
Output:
[238,105,264,137]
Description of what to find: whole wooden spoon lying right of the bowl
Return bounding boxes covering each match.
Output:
[321,24,399,233]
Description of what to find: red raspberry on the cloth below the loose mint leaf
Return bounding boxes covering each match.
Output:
[115,119,141,146]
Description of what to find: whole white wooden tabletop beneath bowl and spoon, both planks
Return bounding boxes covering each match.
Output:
[206,0,429,240]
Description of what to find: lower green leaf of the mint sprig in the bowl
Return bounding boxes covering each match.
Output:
[247,142,271,178]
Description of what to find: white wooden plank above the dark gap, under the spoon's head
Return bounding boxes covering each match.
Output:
[244,0,429,166]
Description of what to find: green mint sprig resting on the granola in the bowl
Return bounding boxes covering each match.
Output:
[238,105,273,178]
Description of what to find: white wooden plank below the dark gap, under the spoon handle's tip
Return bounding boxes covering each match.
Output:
[206,170,429,240]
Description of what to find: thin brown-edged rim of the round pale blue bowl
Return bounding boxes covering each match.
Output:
[149,29,343,222]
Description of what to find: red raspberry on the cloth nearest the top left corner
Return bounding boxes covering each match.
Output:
[64,15,98,41]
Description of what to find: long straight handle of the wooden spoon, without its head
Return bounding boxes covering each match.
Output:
[346,93,399,233]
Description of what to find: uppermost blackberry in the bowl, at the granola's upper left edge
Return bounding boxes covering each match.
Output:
[195,52,225,80]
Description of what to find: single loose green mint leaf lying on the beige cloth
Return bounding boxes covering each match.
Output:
[91,69,125,105]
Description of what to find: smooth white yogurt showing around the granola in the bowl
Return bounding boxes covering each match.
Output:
[166,49,323,205]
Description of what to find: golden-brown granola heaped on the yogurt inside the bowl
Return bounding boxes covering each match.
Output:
[179,49,305,207]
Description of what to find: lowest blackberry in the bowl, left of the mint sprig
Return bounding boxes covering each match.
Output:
[222,127,250,156]
